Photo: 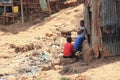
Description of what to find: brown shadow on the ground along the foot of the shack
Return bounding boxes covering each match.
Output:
[59,56,120,76]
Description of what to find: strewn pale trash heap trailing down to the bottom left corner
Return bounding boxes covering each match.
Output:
[0,50,52,80]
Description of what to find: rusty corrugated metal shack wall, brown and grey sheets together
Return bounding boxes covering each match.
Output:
[85,0,120,57]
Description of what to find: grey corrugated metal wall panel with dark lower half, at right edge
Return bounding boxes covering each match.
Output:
[102,0,120,56]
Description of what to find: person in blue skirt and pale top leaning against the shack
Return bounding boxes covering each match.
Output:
[74,20,85,52]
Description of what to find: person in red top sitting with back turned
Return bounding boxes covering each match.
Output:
[63,37,78,60]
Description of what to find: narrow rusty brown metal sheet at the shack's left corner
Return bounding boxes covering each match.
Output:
[85,0,101,57]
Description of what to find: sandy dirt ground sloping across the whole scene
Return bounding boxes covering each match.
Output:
[0,4,120,80]
